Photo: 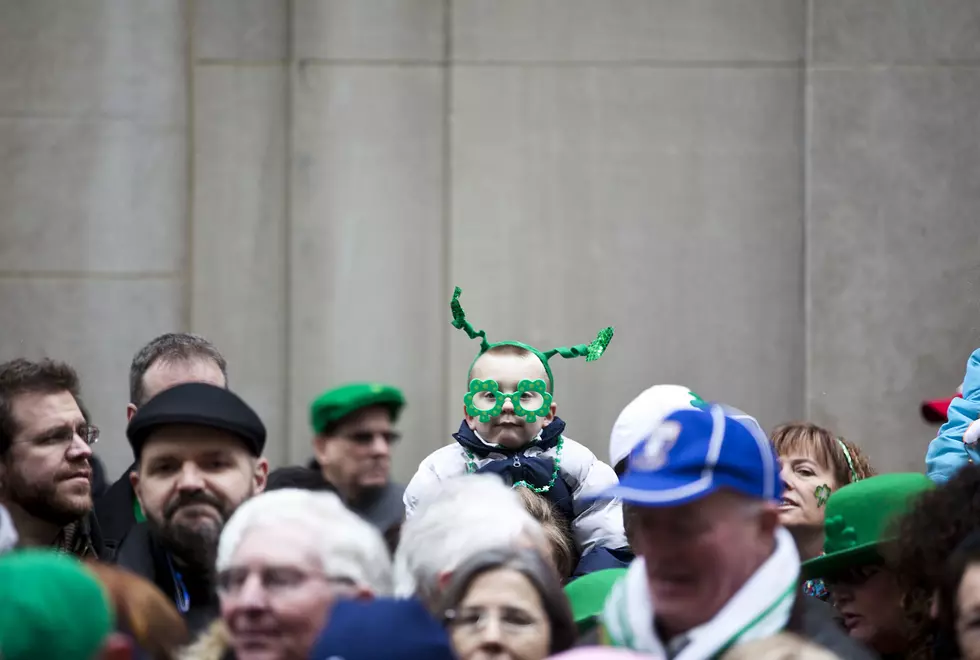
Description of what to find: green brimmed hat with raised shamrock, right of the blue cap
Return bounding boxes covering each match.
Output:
[802,473,934,580]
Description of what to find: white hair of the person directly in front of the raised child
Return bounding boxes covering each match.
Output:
[395,474,557,609]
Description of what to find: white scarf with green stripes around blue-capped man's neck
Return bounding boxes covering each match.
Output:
[602,527,800,660]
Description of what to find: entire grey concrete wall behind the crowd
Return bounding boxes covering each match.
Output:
[0,0,980,478]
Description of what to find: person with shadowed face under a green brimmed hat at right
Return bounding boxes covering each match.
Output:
[801,473,934,657]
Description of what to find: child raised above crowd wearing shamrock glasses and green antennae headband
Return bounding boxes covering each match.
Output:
[404,287,628,568]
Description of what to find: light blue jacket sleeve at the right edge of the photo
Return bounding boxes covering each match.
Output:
[926,348,980,483]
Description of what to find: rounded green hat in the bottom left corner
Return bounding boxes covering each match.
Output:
[0,550,115,660]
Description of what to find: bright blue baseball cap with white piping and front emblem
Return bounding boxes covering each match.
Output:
[601,404,783,507]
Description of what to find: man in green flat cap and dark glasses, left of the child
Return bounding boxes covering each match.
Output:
[310,383,405,533]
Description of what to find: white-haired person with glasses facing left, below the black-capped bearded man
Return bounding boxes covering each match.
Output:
[183,489,391,660]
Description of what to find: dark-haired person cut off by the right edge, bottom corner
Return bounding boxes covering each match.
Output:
[937,532,980,660]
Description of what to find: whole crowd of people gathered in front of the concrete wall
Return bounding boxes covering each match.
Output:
[0,289,980,660]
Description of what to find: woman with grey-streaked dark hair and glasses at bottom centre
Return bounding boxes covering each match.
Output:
[439,549,576,660]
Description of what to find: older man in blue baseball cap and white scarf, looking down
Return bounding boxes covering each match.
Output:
[588,404,872,660]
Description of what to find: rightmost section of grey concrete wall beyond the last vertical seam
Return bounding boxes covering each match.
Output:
[806,0,980,470]
